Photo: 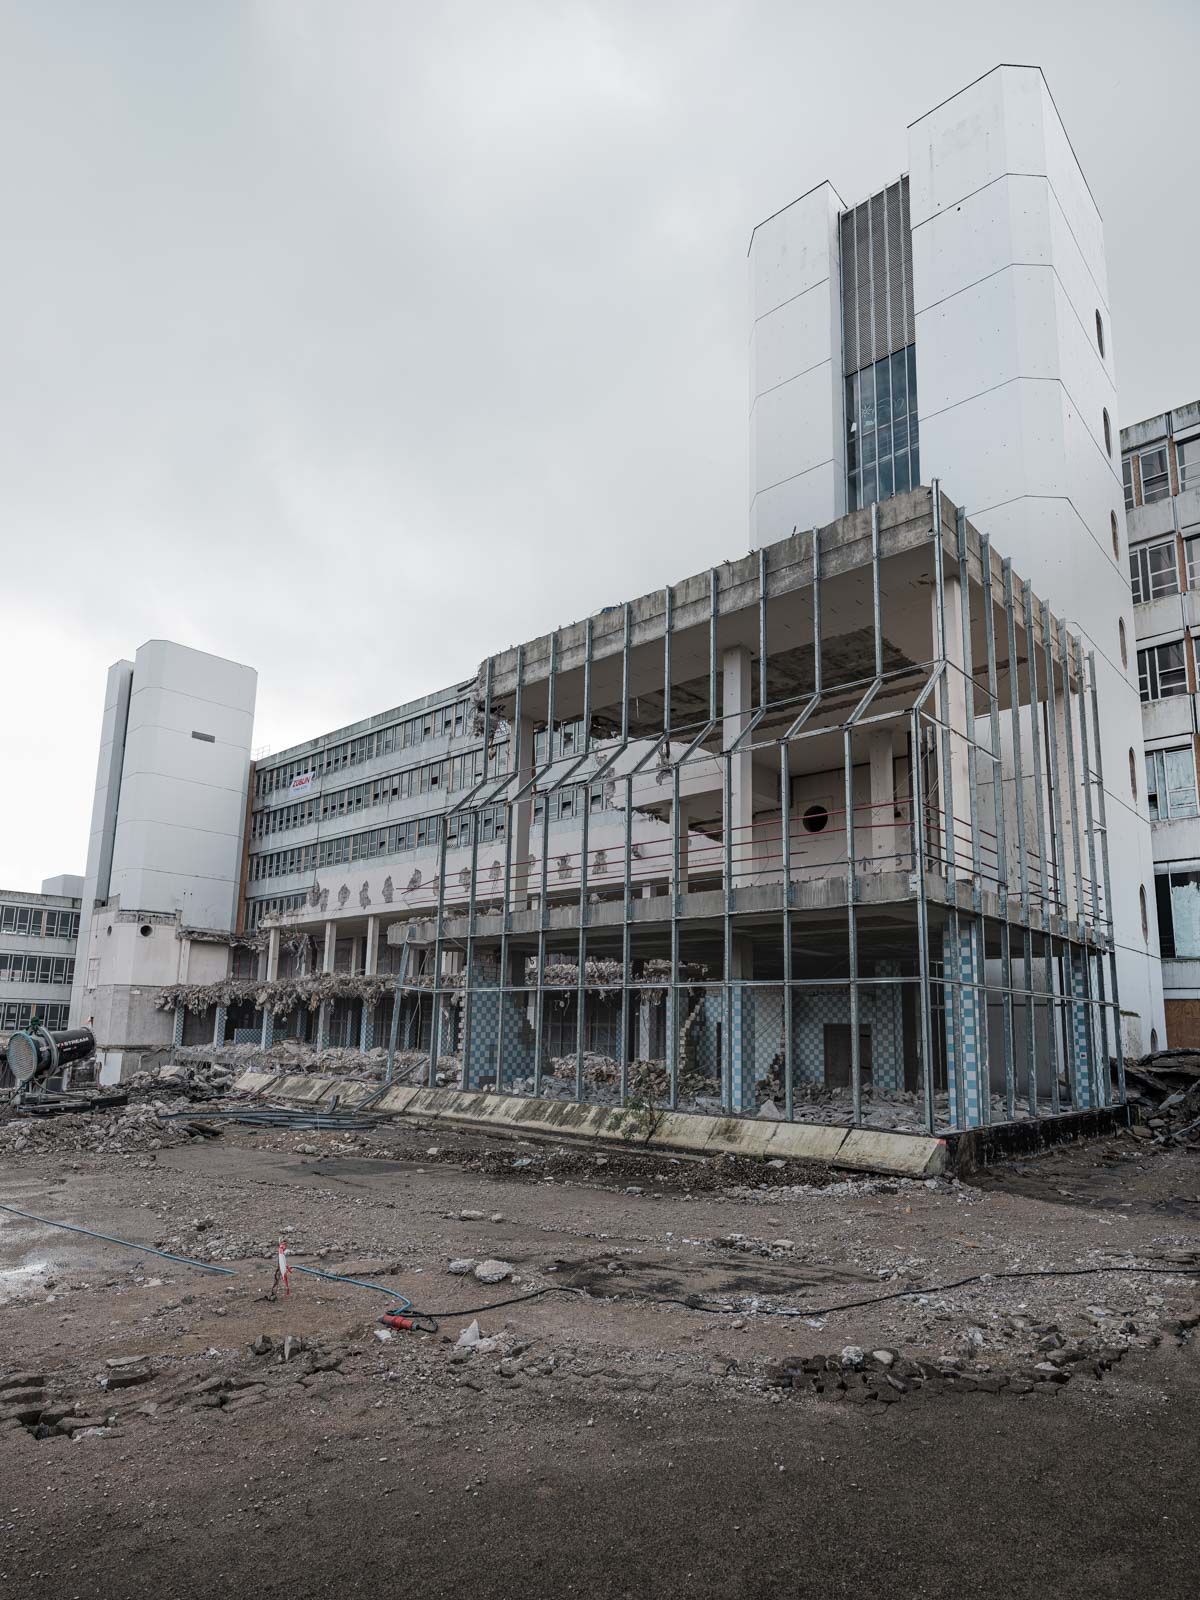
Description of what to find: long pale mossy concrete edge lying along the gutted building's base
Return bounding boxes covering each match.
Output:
[235,1072,950,1178]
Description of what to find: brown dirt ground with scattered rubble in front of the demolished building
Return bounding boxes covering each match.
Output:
[0,1125,1200,1600]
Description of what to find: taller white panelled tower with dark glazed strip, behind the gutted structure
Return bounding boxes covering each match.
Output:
[750,66,1165,1054]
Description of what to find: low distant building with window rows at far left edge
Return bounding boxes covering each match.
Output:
[0,877,83,1045]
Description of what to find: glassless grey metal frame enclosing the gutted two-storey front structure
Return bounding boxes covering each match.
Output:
[256,482,1125,1133]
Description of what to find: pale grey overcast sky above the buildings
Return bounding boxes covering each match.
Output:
[0,0,1200,888]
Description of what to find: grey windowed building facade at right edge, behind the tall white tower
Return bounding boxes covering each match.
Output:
[1122,402,1200,1046]
